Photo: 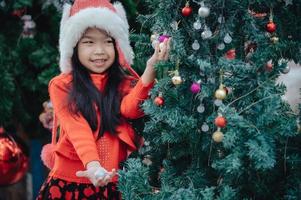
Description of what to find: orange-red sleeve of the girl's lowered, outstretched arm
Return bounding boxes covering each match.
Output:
[48,76,99,166]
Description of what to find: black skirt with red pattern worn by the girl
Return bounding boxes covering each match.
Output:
[37,177,121,200]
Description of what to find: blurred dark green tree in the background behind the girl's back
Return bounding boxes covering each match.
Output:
[0,0,60,137]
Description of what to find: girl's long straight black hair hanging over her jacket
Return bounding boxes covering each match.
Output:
[68,40,125,139]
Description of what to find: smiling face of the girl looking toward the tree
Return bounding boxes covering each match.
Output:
[78,28,115,74]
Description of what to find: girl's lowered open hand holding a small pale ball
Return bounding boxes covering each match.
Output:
[76,161,116,187]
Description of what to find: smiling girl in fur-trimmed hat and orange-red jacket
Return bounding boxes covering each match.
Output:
[37,0,169,199]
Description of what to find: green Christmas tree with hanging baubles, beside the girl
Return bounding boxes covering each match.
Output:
[119,0,301,200]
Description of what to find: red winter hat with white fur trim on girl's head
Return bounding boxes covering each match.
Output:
[59,0,139,77]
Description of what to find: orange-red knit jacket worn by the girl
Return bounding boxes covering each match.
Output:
[48,74,153,183]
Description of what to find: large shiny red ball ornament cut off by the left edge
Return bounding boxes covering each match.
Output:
[0,131,29,186]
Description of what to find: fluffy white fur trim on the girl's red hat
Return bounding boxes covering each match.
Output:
[59,3,134,73]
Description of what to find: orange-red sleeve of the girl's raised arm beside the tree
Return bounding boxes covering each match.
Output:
[120,78,154,119]
